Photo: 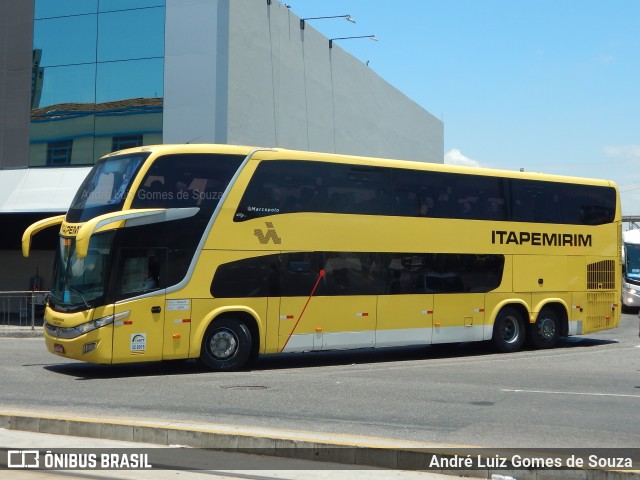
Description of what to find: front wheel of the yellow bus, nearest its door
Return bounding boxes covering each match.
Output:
[200,318,252,372]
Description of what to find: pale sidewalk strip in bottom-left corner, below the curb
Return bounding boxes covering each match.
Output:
[0,428,476,480]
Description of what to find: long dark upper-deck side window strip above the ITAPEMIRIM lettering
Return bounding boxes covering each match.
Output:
[235,161,616,225]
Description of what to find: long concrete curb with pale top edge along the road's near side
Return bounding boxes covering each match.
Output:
[0,411,640,480]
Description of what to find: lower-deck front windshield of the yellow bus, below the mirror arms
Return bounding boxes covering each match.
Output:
[51,231,115,311]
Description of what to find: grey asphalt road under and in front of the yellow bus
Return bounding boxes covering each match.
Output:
[0,315,640,448]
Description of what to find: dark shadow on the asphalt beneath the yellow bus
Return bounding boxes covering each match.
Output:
[44,337,619,380]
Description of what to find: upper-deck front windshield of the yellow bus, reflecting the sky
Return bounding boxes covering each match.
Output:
[67,153,149,223]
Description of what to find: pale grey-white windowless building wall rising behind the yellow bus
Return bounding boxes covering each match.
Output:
[163,0,444,163]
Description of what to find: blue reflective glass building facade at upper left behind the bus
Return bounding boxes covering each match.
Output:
[29,0,166,166]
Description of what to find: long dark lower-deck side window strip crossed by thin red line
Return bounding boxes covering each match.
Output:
[211,252,504,298]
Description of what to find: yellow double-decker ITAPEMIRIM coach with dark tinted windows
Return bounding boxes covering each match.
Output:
[22,145,621,370]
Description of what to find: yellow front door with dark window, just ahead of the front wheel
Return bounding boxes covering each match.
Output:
[113,248,166,363]
